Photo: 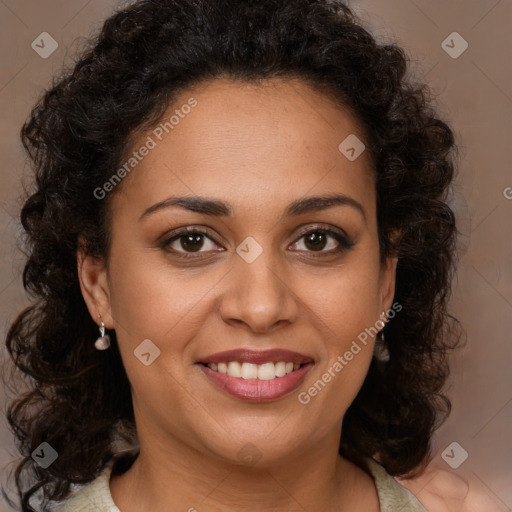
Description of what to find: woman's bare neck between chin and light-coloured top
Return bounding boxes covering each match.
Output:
[110,422,378,512]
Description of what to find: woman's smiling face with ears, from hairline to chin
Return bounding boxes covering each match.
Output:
[81,79,396,464]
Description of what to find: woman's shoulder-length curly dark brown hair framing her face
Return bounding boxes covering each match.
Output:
[1,0,460,511]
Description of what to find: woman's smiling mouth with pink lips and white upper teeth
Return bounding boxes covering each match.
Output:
[197,349,315,402]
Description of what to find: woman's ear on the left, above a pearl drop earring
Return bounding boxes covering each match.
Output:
[77,239,115,329]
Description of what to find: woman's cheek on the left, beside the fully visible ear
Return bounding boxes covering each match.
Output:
[105,248,211,410]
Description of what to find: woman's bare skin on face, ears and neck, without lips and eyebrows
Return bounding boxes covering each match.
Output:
[78,79,396,512]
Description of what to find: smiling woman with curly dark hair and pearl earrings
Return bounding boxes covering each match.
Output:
[7,0,466,512]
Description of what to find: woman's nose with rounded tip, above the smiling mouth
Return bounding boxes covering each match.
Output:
[220,251,299,333]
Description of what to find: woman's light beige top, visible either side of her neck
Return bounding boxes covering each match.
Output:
[59,457,428,512]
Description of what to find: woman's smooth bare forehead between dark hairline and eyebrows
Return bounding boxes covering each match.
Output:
[114,79,374,217]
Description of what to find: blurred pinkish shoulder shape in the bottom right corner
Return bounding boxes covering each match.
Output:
[397,468,502,512]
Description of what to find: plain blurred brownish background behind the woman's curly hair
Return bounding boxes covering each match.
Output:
[0,0,512,512]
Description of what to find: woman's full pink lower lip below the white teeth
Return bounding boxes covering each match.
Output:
[199,363,314,402]
